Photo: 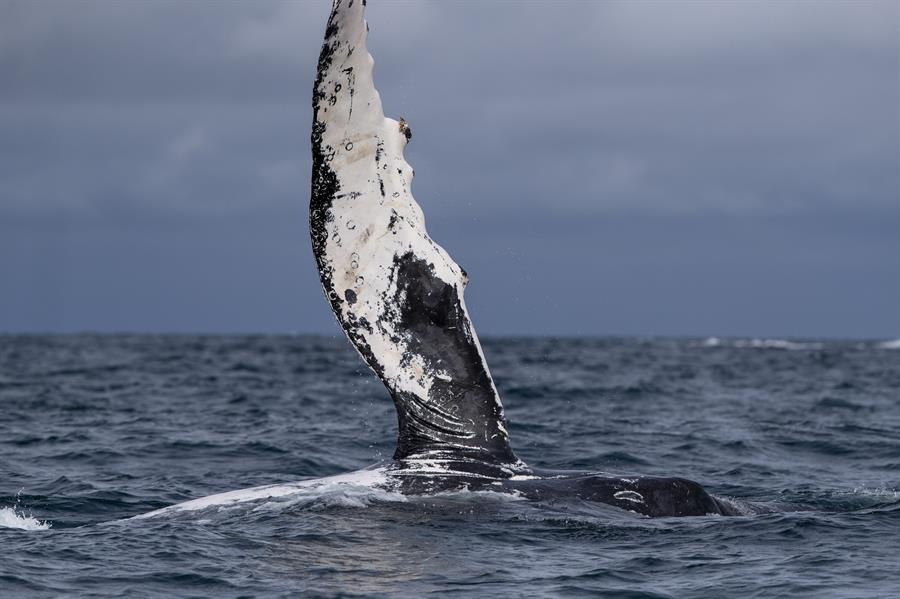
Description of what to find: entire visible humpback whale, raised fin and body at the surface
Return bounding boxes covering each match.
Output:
[138,0,748,518]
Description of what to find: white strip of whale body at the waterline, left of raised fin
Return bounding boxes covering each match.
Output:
[132,468,387,519]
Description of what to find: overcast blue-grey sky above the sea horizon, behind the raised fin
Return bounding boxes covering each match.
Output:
[0,0,900,339]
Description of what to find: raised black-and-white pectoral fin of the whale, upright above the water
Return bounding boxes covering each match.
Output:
[309,0,517,464]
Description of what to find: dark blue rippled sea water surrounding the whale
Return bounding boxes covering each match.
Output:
[0,335,900,597]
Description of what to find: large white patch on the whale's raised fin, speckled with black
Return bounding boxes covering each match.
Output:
[317,2,474,404]
